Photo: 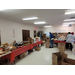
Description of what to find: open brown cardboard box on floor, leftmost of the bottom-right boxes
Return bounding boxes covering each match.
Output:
[52,52,67,65]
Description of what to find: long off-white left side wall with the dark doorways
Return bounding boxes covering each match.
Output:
[0,18,40,44]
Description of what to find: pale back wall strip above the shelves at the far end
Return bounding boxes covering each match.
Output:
[41,25,75,33]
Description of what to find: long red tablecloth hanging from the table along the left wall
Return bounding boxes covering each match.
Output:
[6,41,42,63]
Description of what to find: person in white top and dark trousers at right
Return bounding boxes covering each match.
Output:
[66,32,75,51]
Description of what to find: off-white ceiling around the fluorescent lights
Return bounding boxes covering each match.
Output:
[0,9,75,27]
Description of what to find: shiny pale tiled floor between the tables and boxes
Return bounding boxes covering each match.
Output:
[12,46,75,65]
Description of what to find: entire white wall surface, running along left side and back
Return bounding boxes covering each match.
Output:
[0,18,75,44]
